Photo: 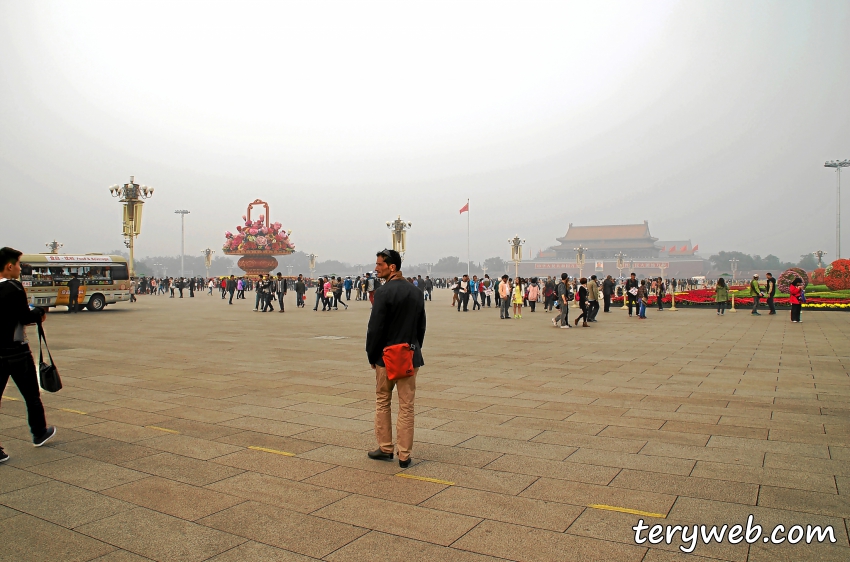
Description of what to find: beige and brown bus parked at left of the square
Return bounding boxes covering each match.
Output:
[21,254,130,312]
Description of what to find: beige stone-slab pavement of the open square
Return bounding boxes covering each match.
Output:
[0,291,850,562]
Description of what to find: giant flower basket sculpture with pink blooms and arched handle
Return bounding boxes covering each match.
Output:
[222,199,295,276]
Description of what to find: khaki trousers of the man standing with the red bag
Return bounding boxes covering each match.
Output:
[375,365,419,461]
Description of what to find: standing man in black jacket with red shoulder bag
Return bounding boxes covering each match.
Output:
[366,250,425,468]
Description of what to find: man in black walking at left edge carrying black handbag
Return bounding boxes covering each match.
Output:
[0,248,56,463]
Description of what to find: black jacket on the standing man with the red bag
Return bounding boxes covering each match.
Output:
[366,279,425,368]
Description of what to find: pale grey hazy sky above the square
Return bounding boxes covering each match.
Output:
[0,0,850,263]
